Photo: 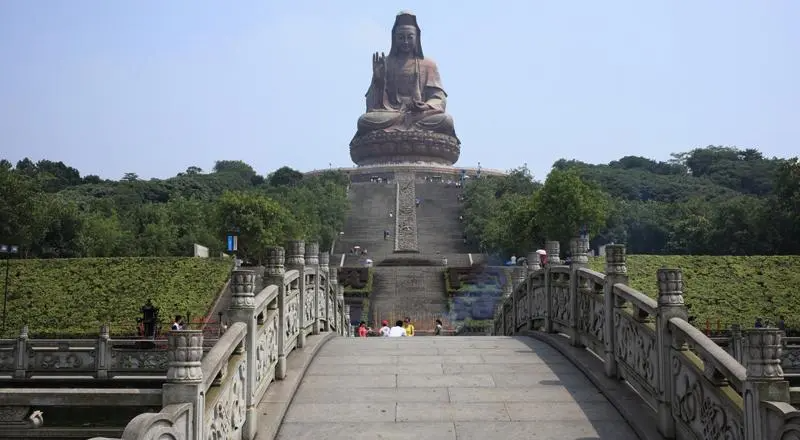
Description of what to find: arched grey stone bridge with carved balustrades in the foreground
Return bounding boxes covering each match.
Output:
[0,239,800,440]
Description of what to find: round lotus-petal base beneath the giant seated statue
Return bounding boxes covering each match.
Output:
[350,130,461,166]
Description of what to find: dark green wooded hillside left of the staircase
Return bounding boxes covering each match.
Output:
[0,159,348,260]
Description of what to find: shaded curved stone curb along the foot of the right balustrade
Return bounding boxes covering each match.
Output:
[521,330,664,440]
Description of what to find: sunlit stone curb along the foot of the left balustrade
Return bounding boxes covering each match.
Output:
[255,332,339,440]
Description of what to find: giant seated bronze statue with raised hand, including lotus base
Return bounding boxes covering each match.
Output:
[350,12,461,165]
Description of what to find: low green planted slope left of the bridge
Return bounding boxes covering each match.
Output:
[0,257,233,338]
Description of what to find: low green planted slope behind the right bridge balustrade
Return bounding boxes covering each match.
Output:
[589,255,800,330]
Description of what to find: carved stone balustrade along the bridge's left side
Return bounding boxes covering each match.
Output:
[83,240,350,440]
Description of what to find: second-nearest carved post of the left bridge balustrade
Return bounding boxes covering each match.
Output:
[228,269,259,440]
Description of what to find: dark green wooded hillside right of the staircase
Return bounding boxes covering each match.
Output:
[464,146,800,256]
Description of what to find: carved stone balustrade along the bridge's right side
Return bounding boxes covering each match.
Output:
[494,238,800,440]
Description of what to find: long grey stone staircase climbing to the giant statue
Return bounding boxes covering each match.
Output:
[331,173,490,332]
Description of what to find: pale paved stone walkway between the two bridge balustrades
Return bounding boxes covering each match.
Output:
[278,336,637,440]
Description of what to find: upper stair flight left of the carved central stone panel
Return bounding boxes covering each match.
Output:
[331,182,397,266]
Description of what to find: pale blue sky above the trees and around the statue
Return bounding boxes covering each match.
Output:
[0,0,800,179]
